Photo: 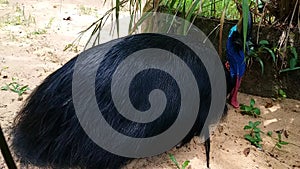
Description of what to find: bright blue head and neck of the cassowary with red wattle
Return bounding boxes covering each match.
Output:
[225,12,252,108]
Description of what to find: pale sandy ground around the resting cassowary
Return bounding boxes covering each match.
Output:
[0,0,300,169]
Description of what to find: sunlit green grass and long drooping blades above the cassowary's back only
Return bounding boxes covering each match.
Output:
[68,0,248,48]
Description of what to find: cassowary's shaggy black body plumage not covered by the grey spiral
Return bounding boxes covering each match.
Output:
[13,34,237,169]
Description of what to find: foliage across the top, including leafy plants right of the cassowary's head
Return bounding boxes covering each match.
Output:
[61,0,300,78]
